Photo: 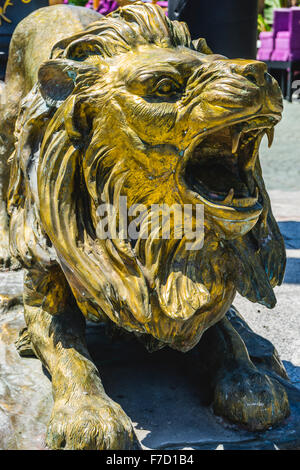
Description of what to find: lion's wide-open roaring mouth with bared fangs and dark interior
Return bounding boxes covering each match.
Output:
[182,117,274,210]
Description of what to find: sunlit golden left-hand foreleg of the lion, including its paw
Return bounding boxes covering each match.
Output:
[24,272,137,450]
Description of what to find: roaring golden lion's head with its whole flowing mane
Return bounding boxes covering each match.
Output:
[9,2,285,351]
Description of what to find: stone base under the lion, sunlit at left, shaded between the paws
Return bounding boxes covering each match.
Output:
[0,300,300,450]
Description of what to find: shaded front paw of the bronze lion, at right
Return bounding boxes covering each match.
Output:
[213,367,290,431]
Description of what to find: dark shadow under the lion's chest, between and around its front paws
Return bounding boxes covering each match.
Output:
[87,325,300,449]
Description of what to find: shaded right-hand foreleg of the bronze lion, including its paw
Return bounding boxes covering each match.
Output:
[198,317,289,431]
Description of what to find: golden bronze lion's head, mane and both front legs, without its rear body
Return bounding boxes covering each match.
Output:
[1,2,289,449]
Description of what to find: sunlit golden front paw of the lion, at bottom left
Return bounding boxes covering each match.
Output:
[46,396,140,450]
